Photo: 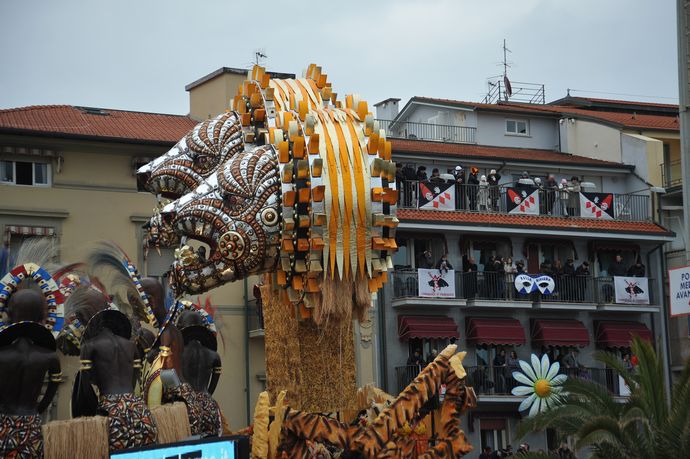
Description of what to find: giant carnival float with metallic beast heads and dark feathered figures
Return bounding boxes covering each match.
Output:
[0,65,476,459]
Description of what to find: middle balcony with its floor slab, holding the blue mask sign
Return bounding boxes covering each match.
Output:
[392,270,658,312]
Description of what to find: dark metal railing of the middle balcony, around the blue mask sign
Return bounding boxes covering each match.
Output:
[392,270,655,307]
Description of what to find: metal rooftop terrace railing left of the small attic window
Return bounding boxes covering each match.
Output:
[377,120,477,143]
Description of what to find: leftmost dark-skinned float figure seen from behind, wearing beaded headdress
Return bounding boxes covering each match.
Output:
[0,255,63,458]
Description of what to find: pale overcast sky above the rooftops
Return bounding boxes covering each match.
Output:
[0,0,678,114]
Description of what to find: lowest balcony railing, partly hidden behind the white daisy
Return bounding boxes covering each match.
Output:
[395,365,625,395]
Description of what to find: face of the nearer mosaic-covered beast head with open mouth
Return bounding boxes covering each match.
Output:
[160,146,280,294]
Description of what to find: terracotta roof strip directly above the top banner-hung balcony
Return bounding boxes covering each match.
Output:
[390,138,634,169]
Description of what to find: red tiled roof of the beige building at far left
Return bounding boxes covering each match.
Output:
[0,105,197,144]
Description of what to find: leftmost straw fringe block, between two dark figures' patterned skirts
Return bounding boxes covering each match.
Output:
[43,416,108,459]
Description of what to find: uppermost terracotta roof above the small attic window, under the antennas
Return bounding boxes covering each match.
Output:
[403,96,680,131]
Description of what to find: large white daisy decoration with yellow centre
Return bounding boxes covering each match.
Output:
[512,354,567,416]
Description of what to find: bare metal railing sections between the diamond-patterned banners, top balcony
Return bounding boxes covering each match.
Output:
[398,180,651,221]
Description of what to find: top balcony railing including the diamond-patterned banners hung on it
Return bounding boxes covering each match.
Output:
[398,180,651,221]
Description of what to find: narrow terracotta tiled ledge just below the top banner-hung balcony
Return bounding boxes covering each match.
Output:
[397,209,673,236]
